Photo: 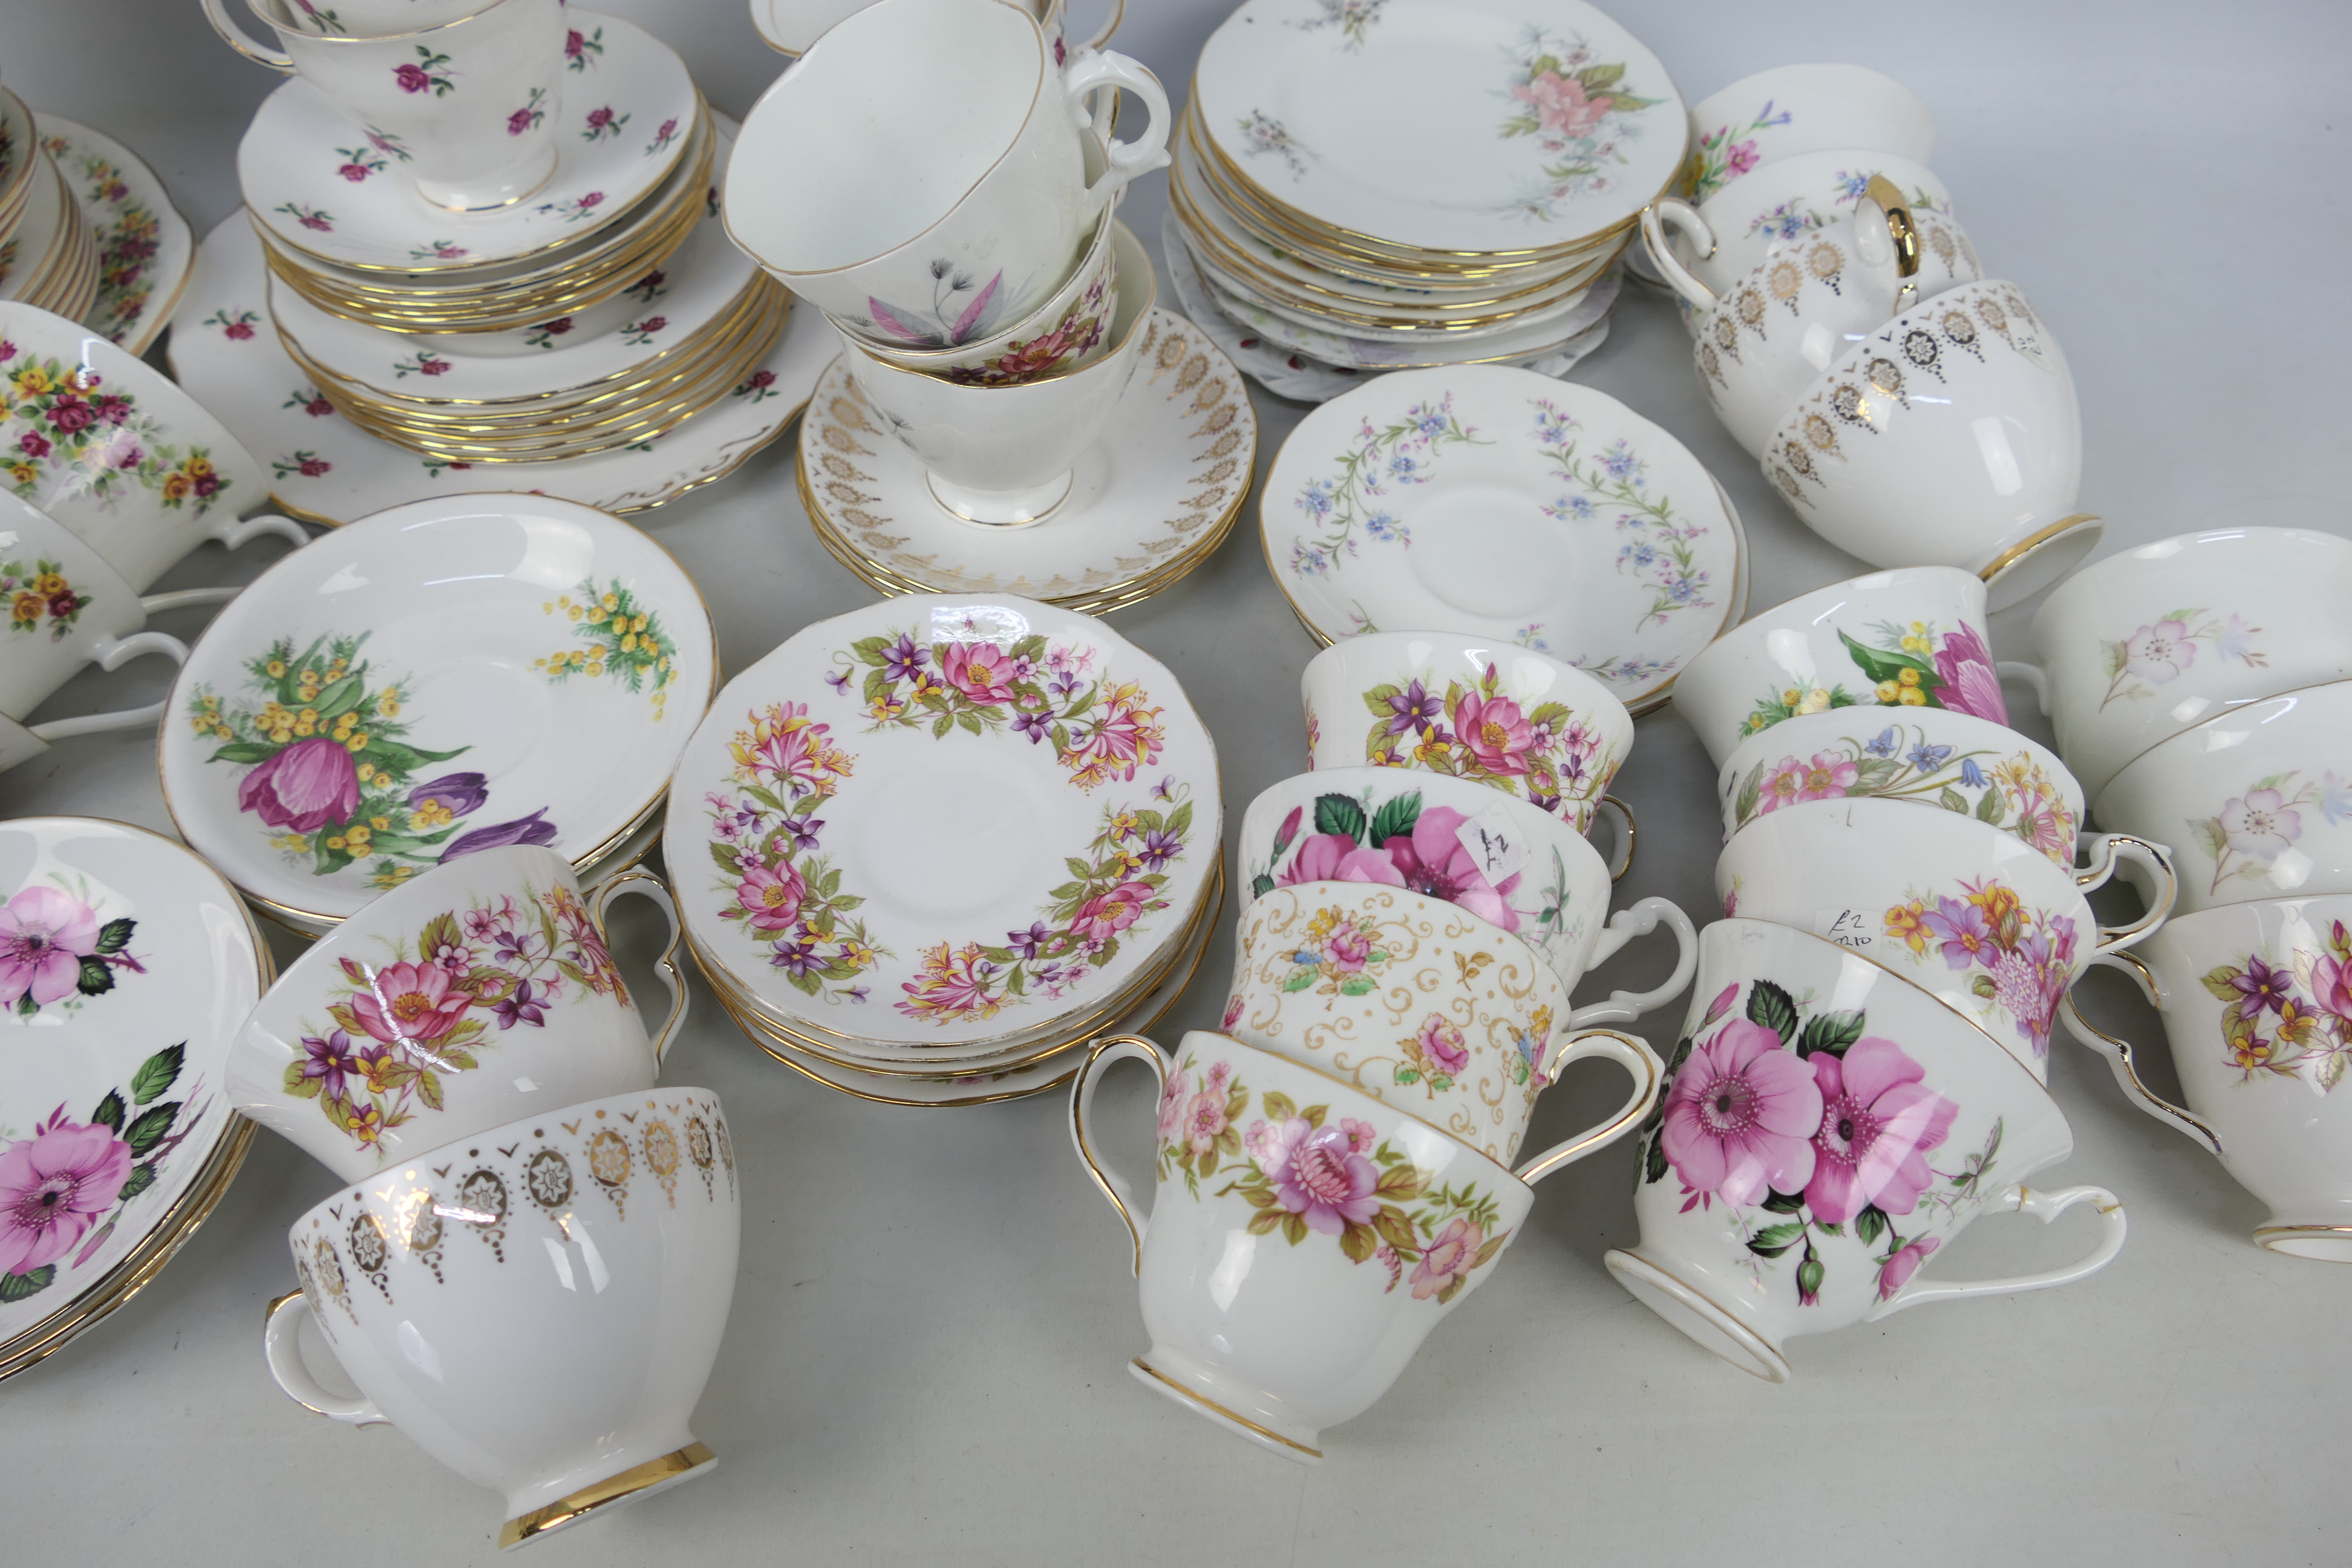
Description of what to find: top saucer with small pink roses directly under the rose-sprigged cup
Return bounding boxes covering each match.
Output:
[238,11,701,273]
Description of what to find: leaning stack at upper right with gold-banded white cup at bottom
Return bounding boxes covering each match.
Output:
[1644,66,2103,609]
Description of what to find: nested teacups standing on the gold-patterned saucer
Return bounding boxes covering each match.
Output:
[725,0,1166,524]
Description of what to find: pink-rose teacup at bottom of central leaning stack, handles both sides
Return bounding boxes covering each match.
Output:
[1070,1030,1661,1465]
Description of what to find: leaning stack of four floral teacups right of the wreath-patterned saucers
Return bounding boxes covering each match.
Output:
[1073,632,1696,1462]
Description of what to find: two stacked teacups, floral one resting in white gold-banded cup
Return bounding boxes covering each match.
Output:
[228,846,741,1547]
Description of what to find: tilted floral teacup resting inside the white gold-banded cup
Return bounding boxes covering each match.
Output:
[228,844,687,1183]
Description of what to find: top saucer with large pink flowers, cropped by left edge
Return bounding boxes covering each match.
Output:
[0,815,270,1377]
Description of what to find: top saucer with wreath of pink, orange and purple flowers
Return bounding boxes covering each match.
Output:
[663,595,1223,1056]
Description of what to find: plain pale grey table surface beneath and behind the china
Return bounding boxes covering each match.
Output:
[0,0,2352,1568]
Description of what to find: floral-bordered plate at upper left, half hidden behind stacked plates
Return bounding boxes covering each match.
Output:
[40,115,195,355]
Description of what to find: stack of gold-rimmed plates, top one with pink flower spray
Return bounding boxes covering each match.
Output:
[1169,0,1689,390]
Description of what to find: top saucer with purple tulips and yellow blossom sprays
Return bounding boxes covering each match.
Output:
[160,496,717,929]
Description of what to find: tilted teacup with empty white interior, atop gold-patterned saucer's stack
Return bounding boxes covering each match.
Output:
[725,0,1169,331]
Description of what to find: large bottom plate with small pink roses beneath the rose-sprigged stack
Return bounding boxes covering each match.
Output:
[169,214,840,526]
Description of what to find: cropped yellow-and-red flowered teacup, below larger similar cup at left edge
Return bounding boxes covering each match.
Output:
[0,491,188,738]
